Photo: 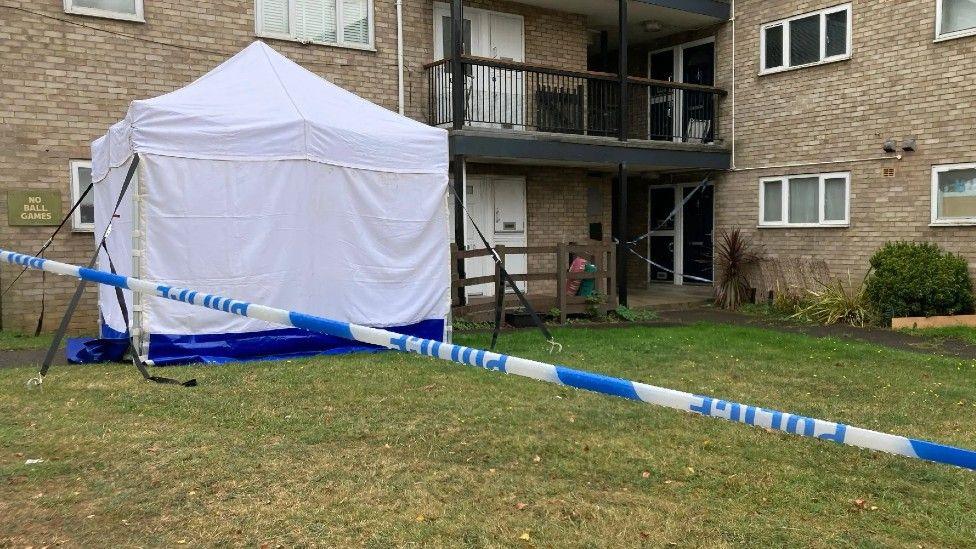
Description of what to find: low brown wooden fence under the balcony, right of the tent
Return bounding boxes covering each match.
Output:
[451,244,617,323]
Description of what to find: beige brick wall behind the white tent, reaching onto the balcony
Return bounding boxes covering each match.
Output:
[0,0,588,333]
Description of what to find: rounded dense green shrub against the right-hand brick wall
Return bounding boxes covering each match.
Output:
[865,242,973,320]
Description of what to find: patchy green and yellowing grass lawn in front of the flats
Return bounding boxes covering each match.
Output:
[0,325,976,547]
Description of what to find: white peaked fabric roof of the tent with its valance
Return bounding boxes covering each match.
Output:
[92,41,448,181]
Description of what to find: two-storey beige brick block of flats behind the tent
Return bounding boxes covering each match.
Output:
[9,0,976,331]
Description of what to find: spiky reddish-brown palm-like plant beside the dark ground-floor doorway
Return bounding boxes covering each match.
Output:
[715,227,763,311]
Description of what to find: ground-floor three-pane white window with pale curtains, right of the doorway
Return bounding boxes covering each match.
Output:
[759,173,851,227]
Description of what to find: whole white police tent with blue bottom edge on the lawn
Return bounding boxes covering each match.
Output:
[92,42,450,364]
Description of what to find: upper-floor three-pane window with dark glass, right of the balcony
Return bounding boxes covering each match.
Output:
[759,0,852,74]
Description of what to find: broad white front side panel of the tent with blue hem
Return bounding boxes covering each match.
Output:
[142,154,450,363]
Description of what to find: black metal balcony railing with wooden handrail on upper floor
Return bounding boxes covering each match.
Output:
[425,56,725,143]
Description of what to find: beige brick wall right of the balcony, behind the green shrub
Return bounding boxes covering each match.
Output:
[715,0,976,277]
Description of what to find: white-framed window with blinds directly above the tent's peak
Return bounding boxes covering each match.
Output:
[255,0,373,49]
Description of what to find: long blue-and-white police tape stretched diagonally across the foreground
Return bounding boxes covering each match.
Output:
[0,250,976,470]
